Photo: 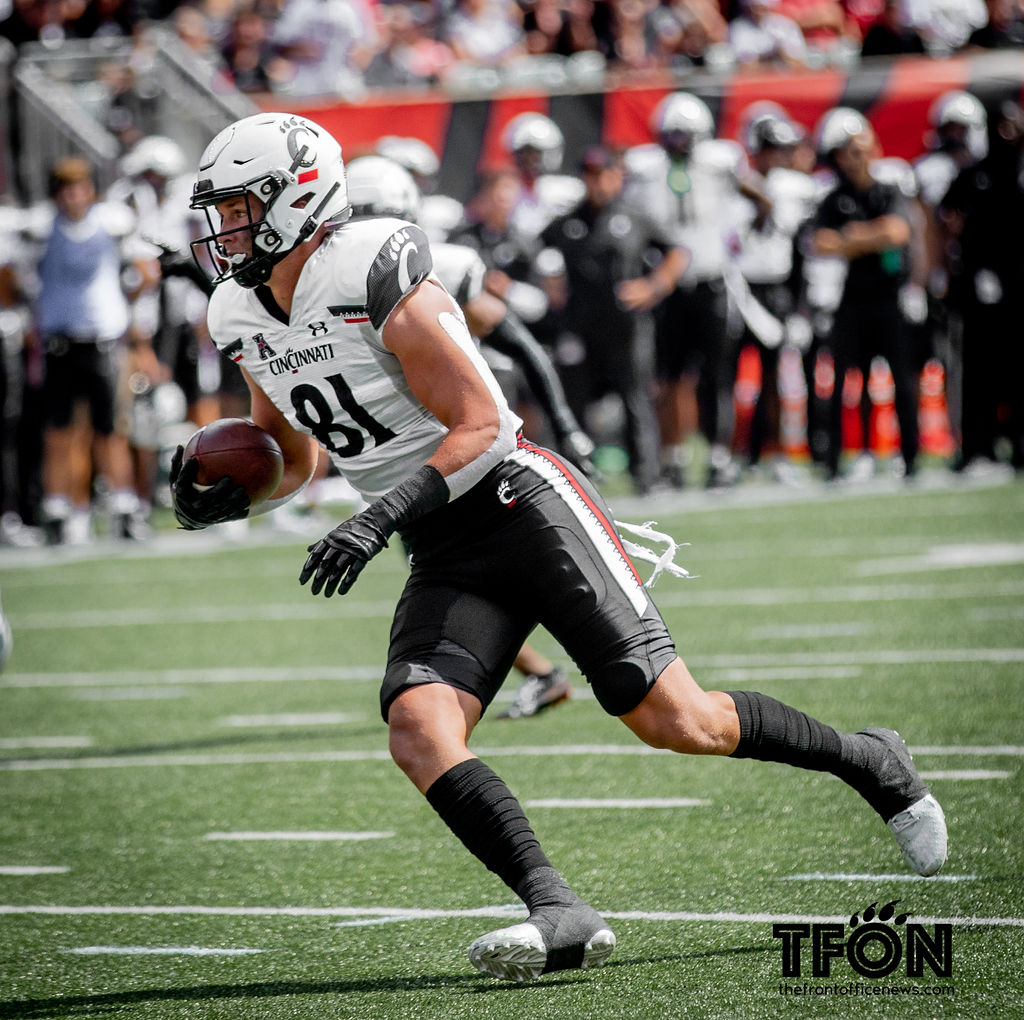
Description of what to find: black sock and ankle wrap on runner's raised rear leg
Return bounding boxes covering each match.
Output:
[727,690,928,821]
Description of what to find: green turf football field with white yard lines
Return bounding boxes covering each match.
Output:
[0,481,1024,1020]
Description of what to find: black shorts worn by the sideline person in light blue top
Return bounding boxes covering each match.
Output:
[43,333,118,435]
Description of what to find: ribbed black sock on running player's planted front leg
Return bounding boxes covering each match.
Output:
[426,758,557,890]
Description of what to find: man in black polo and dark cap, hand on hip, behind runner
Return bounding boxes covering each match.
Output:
[541,147,687,494]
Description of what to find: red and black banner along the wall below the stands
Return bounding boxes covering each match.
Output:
[265,50,1024,200]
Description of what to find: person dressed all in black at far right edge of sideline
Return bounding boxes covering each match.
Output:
[939,101,1024,470]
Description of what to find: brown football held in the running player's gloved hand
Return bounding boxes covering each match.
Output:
[182,418,285,503]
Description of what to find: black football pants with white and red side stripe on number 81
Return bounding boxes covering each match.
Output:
[381,441,676,720]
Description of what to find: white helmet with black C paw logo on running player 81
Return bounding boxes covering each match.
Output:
[190,114,350,288]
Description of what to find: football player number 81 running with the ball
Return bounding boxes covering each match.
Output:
[172,114,946,980]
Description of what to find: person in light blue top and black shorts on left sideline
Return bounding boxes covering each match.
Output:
[36,157,144,543]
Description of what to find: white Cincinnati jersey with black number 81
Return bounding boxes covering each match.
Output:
[209,217,521,500]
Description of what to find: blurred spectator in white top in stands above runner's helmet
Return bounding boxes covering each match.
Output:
[273,0,380,98]
